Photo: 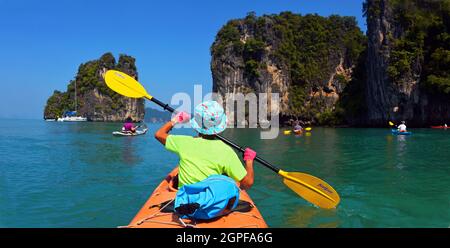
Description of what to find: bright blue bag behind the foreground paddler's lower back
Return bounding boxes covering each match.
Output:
[174,175,239,220]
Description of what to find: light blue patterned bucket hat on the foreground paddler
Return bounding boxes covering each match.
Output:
[191,101,227,135]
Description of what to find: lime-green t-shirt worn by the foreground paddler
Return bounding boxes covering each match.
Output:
[166,135,247,187]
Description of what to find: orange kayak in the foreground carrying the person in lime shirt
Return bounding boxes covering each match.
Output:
[125,167,267,228]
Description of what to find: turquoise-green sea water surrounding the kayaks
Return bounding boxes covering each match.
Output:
[0,120,450,227]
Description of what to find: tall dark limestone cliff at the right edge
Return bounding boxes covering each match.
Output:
[364,0,450,126]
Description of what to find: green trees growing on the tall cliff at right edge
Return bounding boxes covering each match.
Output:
[371,0,450,94]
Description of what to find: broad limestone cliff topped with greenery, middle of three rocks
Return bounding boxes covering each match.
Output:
[211,12,365,124]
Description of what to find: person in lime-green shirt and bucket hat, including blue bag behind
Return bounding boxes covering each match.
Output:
[155,101,256,219]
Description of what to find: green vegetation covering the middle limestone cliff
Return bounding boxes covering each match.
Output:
[211,12,366,125]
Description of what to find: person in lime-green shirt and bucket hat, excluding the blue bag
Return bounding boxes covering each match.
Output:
[155,101,256,190]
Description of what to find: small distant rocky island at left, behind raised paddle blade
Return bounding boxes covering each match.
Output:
[44,53,145,121]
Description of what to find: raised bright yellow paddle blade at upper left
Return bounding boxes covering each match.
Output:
[105,70,152,100]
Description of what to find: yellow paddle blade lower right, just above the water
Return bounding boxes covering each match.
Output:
[278,170,341,209]
